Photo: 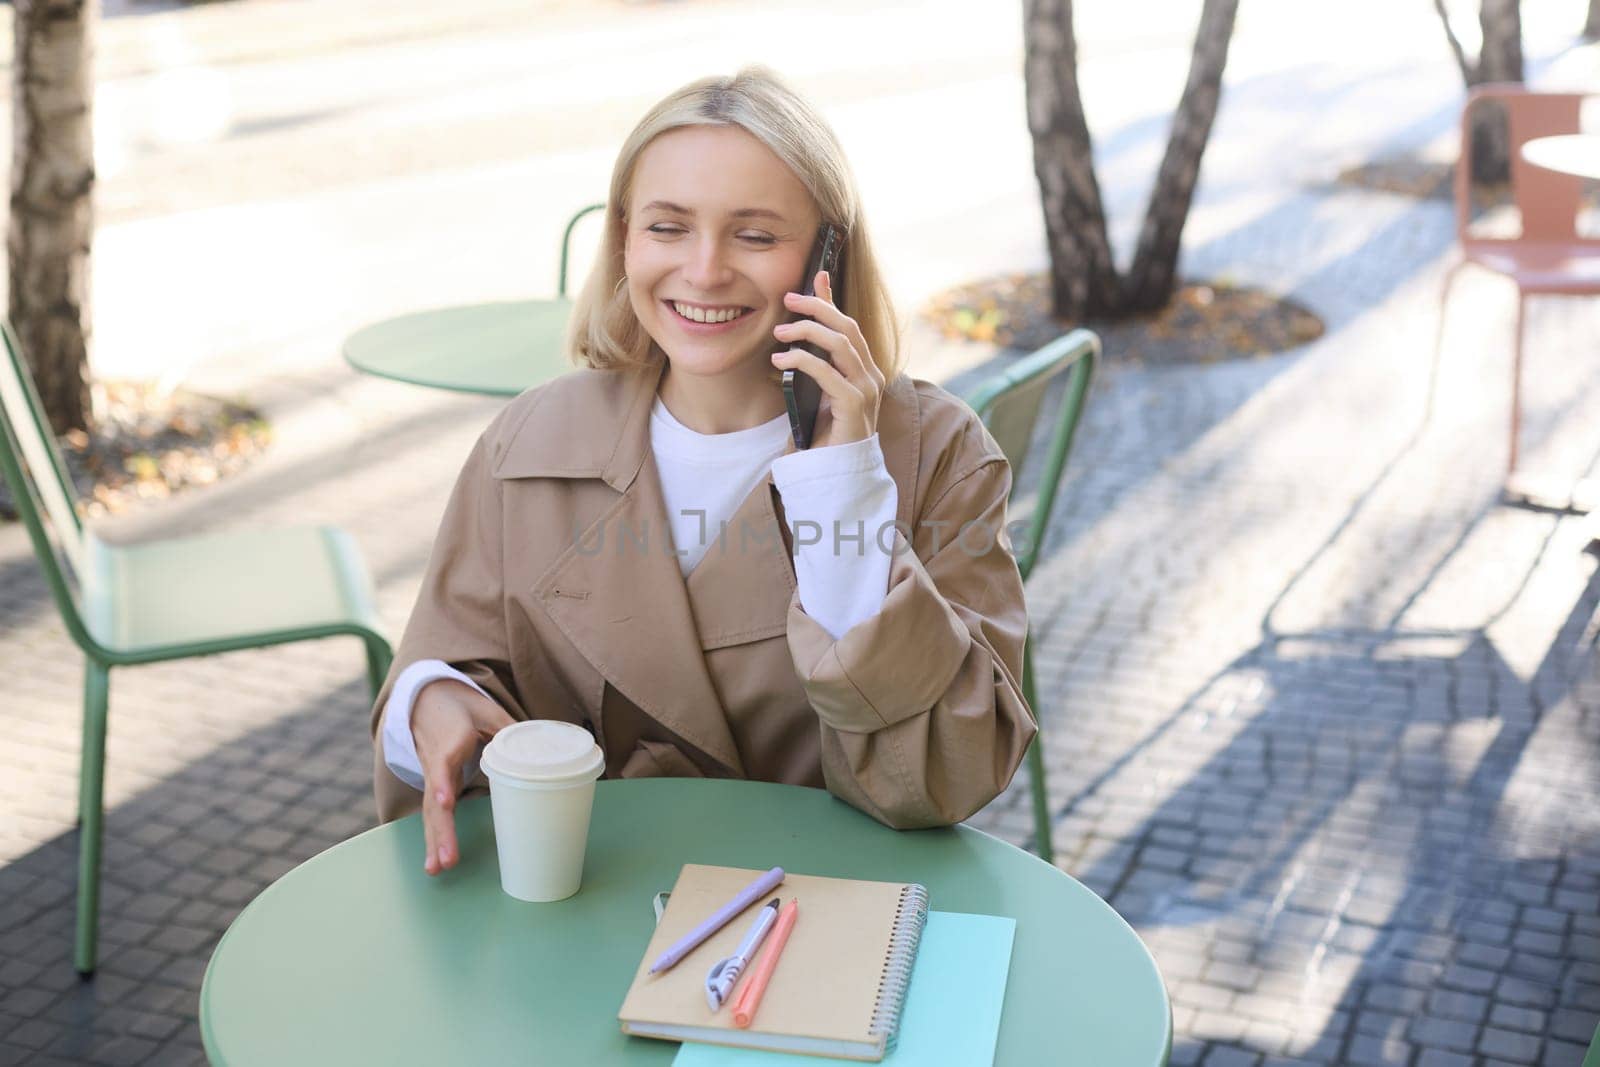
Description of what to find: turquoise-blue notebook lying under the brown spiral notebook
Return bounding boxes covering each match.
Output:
[672,912,1016,1067]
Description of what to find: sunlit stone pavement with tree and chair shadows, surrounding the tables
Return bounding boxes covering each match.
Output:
[0,0,1600,1067]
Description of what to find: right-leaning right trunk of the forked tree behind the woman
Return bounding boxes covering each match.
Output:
[1123,0,1238,312]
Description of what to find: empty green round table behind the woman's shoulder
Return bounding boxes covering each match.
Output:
[344,299,573,397]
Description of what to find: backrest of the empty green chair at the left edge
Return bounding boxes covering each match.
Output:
[0,322,93,649]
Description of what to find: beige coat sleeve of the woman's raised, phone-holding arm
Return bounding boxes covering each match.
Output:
[789,456,1035,829]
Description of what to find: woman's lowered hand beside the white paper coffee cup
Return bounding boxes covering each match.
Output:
[411,678,514,875]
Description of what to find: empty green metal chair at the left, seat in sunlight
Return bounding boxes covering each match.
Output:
[0,323,390,977]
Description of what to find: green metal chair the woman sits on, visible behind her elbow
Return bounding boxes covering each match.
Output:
[968,330,1101,864]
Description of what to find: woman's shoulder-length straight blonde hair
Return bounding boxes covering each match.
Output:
[566,67,901,379]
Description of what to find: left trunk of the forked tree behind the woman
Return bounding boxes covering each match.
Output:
[1022,0,1120,320]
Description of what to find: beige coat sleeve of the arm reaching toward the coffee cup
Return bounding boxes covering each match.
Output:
[370,422,528,822]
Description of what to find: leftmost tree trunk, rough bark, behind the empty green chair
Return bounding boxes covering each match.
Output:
[6,0,99,434]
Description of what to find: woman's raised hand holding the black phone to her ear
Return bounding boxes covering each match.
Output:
[773,270,885,448]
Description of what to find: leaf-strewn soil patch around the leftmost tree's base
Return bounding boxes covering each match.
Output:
[0,382,272,520]
